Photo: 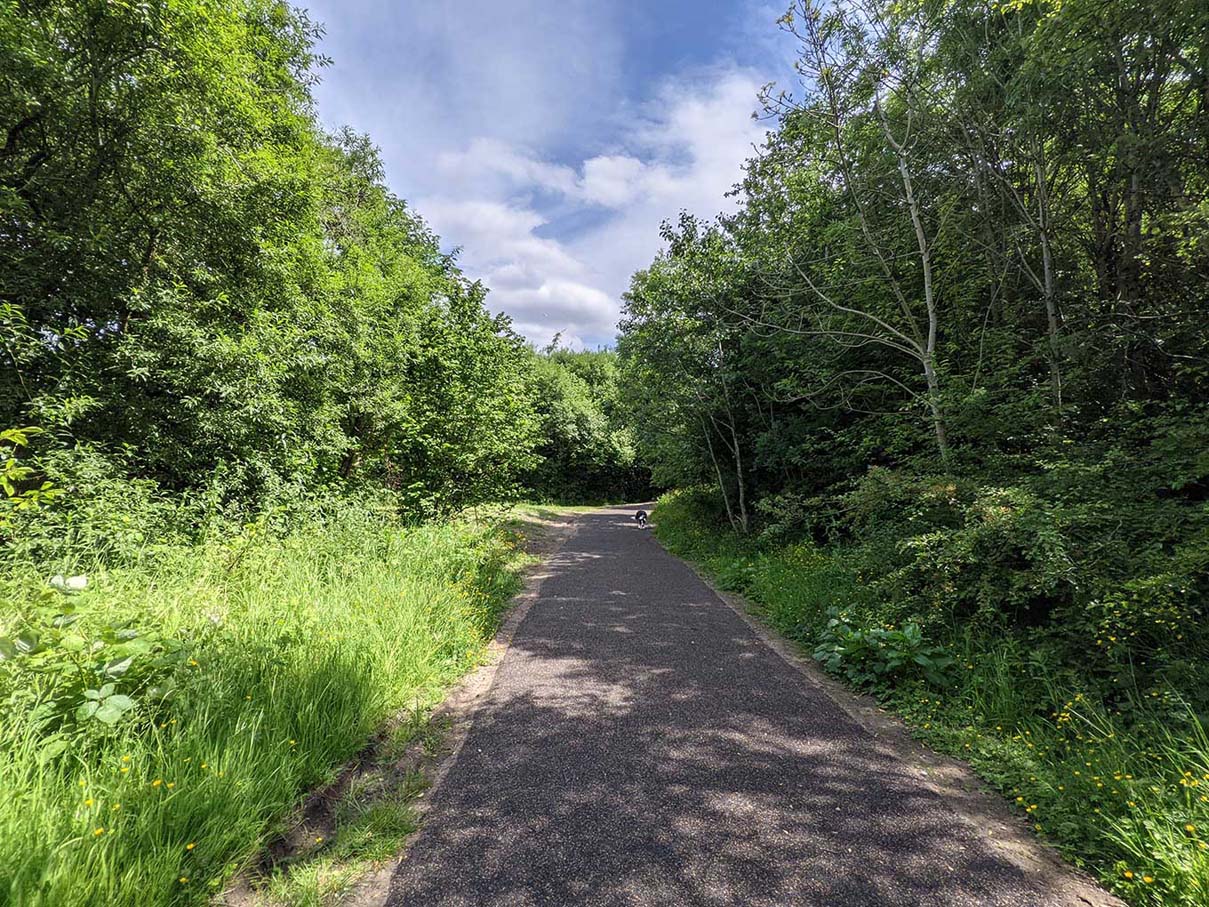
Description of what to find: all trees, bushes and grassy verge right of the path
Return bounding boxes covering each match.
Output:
[619,0,1209,905]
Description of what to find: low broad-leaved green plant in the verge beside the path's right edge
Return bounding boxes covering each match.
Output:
[814,608,953,688]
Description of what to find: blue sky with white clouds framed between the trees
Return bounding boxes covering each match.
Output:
[297,0,792,348]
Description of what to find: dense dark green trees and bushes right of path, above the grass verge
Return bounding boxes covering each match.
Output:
[619,0,1209,670]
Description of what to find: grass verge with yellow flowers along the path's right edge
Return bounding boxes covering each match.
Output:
[653,495,1209,907]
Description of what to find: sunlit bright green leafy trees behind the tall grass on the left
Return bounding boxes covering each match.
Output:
[0,0,534,522]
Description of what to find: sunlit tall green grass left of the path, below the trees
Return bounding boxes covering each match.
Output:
[0,519,516,907]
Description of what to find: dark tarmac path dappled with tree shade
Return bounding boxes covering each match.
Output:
[389,509,1110,907]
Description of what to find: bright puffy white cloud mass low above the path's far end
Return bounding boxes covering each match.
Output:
[416,69,764,345]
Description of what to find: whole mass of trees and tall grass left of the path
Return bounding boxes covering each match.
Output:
[0,0,619,907]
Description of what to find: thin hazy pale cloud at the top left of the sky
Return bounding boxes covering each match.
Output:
[301,0,624,175]
